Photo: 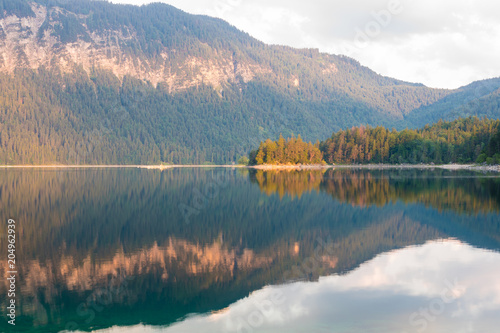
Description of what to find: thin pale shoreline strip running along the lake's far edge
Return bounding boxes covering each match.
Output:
[0,164,500,172]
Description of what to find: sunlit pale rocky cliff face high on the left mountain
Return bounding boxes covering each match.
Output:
[0,3,270,92]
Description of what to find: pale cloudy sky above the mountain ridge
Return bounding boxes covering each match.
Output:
[112,0,500,88]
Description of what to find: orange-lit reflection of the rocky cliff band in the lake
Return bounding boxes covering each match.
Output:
[0,238,272,300]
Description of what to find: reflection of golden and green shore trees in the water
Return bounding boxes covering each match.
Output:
[250,170,500,214]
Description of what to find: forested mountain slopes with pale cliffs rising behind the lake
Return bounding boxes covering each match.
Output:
[0,0,500,164]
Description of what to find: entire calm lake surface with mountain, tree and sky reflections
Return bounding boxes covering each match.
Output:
[0,168,500,333]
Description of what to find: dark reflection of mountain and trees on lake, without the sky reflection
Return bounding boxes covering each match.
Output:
[0,170,500,332]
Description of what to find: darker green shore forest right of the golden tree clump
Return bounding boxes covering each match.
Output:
[321,117,500,164]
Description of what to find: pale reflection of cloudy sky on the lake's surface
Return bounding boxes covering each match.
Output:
[90,241,500,333]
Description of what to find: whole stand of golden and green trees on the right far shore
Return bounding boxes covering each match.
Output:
[249,117,500,165]
